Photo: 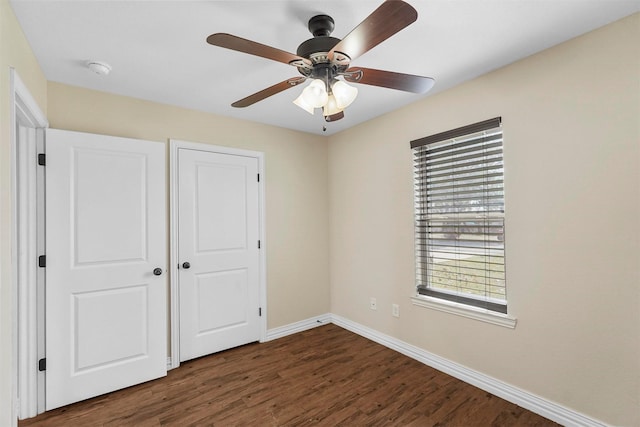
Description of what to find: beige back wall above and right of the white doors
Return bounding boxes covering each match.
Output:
[48,82,329,328]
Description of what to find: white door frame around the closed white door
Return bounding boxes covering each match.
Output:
[168,139,267,369]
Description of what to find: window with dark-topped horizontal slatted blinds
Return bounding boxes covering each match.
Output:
[411,117,507,314]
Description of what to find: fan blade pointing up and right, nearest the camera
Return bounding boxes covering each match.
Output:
[329,0,418,61]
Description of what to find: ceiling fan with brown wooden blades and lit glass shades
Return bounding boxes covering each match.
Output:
[207,0,435,122]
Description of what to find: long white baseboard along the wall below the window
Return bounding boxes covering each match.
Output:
[330,314,607,427]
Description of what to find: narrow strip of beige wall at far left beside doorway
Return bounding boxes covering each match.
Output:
[0,0,47,426]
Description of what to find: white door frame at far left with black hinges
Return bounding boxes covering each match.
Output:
[9,68,49,422]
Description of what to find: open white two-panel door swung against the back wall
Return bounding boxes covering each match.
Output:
[45,129,167,410]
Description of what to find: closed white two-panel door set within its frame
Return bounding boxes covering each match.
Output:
[177,148,260,361]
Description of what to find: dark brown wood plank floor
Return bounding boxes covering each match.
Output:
[19,325,557,427]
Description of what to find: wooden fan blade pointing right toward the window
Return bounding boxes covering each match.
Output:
[344,67,436,93]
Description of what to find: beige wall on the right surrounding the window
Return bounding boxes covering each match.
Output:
[329,14,640,426]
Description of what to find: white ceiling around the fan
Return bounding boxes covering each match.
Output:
[11,0,640,134]
